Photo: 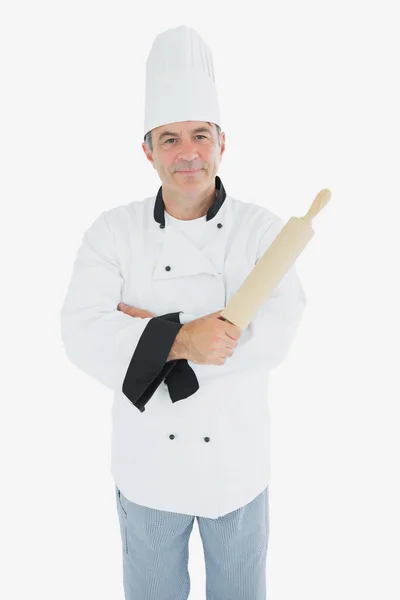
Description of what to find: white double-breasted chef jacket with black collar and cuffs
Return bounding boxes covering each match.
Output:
[60,176,307,519]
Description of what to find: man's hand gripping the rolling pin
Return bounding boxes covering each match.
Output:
[178,310,242,365]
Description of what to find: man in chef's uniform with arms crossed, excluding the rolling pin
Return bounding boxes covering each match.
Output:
[61,26,306,600]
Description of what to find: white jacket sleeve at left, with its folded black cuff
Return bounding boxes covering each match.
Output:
[60,213,182,412]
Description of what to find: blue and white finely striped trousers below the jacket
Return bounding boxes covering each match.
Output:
[115,487,269,600]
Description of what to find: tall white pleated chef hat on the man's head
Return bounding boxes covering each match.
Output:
[144,25,221,135]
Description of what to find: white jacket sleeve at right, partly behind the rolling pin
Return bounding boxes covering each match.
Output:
[220,217,307,370]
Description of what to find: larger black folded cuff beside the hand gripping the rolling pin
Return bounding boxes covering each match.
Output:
[122,313,183,412]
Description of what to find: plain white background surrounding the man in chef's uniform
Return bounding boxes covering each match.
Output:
[0,0,400,600]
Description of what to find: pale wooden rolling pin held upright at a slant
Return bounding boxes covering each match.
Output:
[219,189,331,329]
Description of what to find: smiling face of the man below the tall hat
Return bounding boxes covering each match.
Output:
[142,121,225,195]
